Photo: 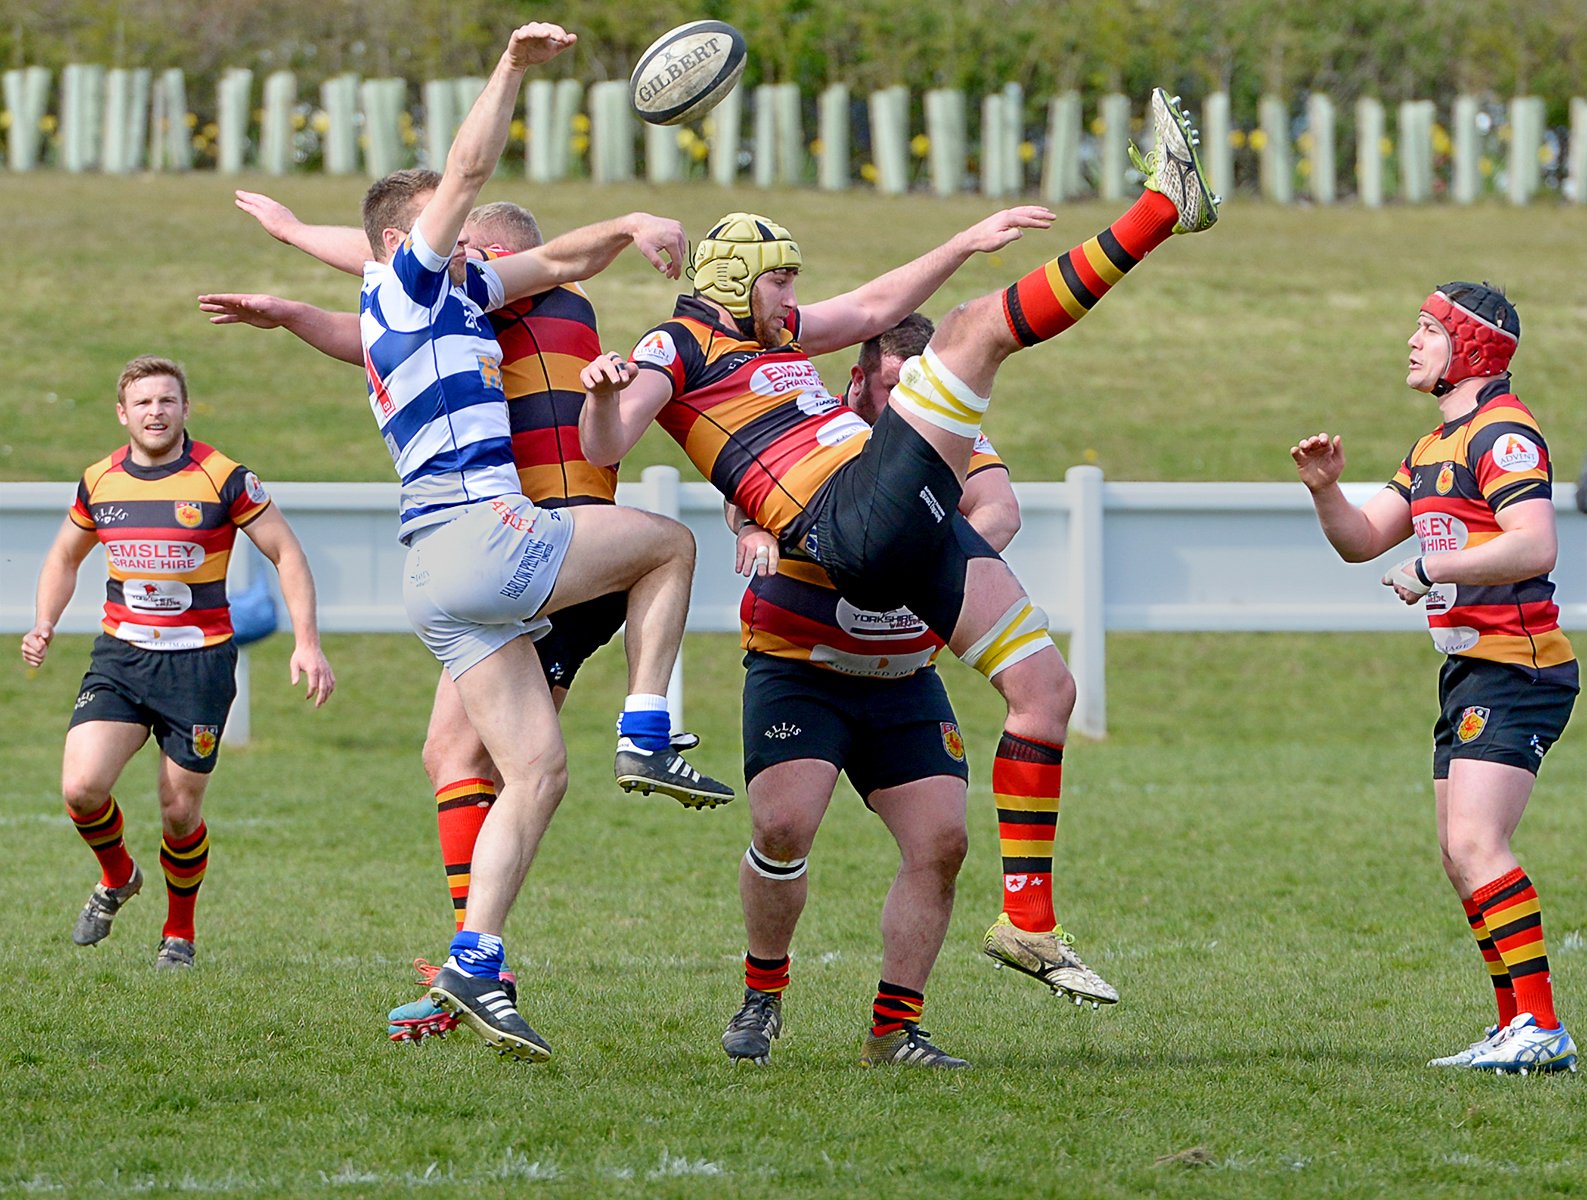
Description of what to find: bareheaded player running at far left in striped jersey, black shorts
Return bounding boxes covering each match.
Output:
[22,356,336,970]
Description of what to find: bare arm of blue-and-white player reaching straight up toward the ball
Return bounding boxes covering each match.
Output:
[414,21,578,265]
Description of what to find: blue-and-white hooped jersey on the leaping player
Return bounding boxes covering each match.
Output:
[359,229,519,541]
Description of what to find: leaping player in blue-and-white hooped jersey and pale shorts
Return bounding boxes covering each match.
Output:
[311,22,732,1060]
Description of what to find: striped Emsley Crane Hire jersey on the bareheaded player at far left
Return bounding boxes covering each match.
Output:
[68,438,270,651]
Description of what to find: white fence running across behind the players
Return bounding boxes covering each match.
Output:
[0,467,1587,737]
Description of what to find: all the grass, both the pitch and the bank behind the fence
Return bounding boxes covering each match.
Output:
[9,175,1587,1200]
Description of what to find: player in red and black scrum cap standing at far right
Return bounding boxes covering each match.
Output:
[1290,283,1581,1073]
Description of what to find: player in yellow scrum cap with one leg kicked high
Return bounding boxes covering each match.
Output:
[579,89,1217,1034]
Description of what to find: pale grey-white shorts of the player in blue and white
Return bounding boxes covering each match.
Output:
[402,495,573,679]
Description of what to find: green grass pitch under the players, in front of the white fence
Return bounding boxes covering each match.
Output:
[9,635,1587,1197]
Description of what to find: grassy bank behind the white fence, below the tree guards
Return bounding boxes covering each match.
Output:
[9,173,1587,481]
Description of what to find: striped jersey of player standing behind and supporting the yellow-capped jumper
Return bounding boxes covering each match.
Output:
[738,433,1008,679]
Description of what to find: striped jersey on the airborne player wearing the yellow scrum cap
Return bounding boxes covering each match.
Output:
[632,295,870,533]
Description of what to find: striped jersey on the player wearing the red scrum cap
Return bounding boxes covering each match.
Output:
[1389,376,1576,681]
